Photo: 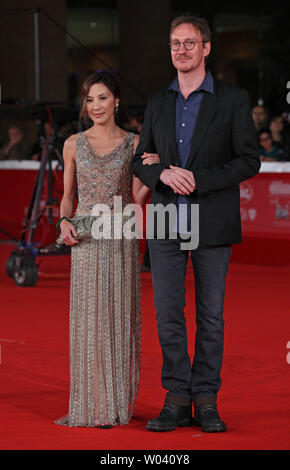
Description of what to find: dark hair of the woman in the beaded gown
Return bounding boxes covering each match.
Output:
[80,71,121,120]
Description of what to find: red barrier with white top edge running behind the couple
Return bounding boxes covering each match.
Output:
[0,162,290,265]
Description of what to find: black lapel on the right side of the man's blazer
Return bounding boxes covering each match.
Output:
[186,92,217,169]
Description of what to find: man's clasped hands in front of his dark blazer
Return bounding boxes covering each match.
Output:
[160,165,196,196]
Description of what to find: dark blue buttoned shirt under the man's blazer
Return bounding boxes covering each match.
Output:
[168,70,214,233]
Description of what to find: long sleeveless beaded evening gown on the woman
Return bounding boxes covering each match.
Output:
[55,132,141,427]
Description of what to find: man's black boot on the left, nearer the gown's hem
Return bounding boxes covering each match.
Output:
[146,400,192,432]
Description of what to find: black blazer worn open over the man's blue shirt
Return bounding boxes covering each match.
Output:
[132,80,260,245]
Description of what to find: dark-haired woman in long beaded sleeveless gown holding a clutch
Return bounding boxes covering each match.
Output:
[55,72,159,428]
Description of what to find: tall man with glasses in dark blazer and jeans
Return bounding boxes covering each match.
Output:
[132,16,260,432]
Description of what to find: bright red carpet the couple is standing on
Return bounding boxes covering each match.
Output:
[0,245,290,450]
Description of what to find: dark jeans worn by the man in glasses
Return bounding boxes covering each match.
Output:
[148,238,232,399]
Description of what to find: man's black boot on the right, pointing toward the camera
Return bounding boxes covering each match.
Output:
[193,401,227,432]
